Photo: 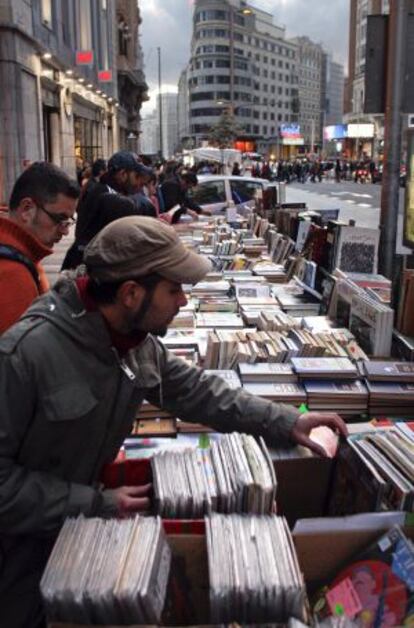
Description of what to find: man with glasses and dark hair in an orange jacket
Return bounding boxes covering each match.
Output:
[0,162,80,334]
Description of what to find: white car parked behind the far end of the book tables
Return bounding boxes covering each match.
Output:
[190,174,277,214]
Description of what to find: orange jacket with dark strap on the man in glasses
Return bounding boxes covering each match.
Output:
[0,216,52,334]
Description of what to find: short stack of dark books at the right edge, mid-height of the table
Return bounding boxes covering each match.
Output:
[364,361,414,417]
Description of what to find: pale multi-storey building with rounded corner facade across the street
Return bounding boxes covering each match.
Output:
[188,0,298,150]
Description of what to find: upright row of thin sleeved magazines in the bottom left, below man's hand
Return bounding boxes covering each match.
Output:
[40,516,171,625]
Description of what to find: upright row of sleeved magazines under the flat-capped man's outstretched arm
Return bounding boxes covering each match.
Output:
[151,433,276,519]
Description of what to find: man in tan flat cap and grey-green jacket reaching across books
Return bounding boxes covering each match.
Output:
[0,216,345,627]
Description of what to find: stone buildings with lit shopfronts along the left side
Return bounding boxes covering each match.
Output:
[0,0,146,204]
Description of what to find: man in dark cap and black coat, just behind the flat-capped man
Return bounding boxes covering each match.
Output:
[62,150,152,270]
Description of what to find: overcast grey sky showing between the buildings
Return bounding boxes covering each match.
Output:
[139,0,350,116]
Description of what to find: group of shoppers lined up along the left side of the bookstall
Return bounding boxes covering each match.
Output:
[0,151,346,628]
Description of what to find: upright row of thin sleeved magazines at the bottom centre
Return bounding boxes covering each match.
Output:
[206,514,306,624]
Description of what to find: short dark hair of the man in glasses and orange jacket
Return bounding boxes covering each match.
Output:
[9,161,80,210]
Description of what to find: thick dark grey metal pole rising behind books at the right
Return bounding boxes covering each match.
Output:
[379,0,408,281]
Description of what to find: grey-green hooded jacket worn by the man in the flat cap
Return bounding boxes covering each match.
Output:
[0,280,298,626]
